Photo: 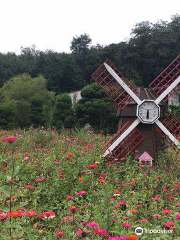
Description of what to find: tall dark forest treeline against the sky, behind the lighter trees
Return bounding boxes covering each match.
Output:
[0,15,180,94]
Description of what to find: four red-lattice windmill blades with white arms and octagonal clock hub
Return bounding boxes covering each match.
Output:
[92,56,180,159]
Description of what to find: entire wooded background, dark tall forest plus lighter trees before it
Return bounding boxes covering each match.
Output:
[0,15,180,131]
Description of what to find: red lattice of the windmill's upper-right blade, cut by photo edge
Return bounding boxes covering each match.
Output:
[149,55,180,102]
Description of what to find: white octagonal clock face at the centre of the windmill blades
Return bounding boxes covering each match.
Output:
[137,100,160,124]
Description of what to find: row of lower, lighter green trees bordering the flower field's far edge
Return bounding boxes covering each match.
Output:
[0,74,117,133]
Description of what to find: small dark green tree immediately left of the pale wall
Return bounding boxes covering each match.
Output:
[52,93,76,129]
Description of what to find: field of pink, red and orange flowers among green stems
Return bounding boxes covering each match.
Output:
[0,129,180,240]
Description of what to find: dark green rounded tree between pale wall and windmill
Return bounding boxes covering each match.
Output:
[75,83,117,133]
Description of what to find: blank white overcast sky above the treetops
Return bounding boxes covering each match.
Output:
[0,0,180,53]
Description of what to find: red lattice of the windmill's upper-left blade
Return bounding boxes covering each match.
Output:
[92,59,137,109]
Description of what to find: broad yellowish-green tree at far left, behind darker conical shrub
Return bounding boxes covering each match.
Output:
[0,74,54,127]
